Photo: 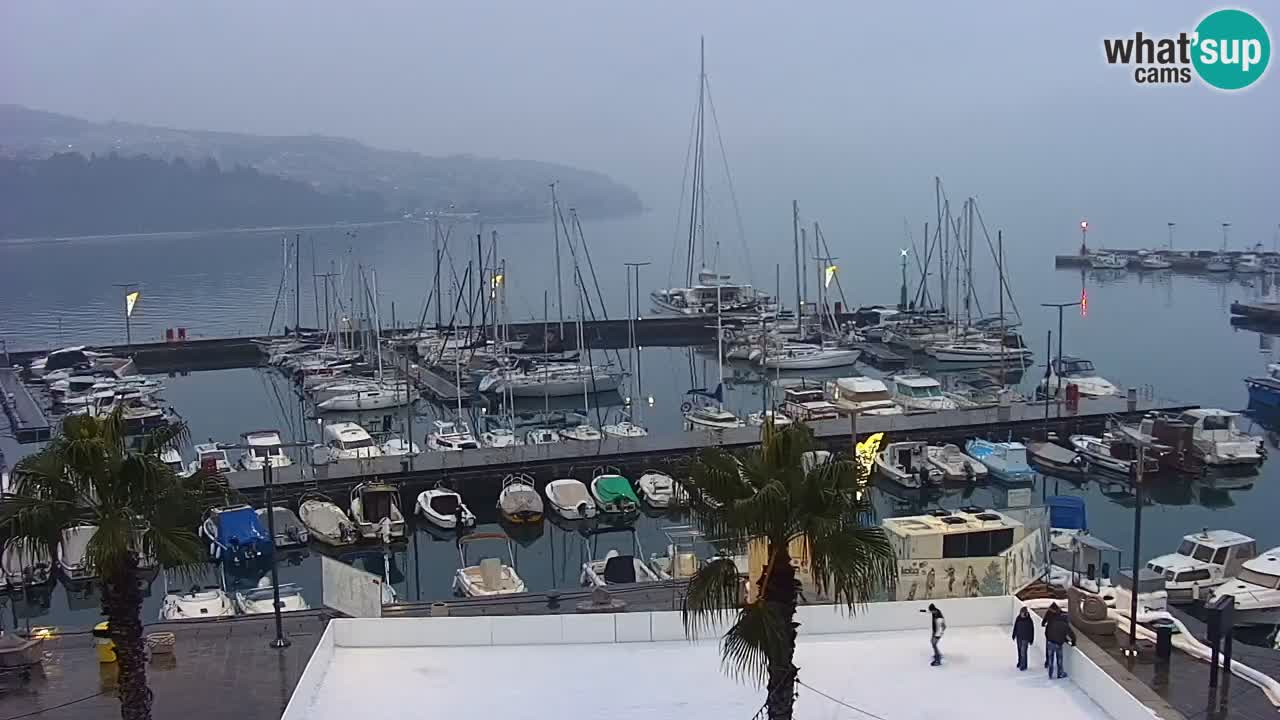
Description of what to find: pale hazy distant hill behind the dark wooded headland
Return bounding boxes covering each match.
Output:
[0,105,643,233]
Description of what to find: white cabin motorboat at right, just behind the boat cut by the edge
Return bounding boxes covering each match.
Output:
[1147,529,1258,603]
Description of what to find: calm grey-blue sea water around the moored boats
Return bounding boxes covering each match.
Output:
[0,219,1280,628]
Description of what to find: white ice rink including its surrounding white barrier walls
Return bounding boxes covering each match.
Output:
[284,597,1153,720]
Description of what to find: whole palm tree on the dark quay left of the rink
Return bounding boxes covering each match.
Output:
[0,411,225,720]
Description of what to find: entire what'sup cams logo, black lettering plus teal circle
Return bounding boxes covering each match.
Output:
[1102,10,1271,90]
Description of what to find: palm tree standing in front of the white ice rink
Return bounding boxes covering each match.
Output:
[684,423,897,720]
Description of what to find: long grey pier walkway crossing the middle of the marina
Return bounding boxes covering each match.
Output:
[227,397,1189,495]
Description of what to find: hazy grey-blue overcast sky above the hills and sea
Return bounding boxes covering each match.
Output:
[0,0,1280,252]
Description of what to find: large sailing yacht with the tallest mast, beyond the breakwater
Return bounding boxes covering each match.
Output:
[649,40,777,319]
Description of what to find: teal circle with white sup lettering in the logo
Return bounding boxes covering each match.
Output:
[1192,10,1271,90]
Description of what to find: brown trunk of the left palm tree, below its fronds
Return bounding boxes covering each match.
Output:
[102,553,151,720]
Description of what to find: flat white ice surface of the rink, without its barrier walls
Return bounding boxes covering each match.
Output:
[294,623,1110,720]
